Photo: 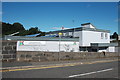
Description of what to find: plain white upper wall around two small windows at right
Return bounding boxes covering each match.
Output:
[79,31,110,46]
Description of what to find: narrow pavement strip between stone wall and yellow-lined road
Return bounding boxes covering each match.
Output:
[0,57,118,69]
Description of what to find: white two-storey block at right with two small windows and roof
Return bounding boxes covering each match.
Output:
[79,23,110,52]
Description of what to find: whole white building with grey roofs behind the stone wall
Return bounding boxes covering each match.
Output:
[17,23,118,52]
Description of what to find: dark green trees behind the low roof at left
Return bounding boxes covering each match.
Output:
[2,22,45,36]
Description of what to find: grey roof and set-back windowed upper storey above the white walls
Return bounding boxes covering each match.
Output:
[46,23,110,38]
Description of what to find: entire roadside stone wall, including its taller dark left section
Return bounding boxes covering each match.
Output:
[0,41,120,61]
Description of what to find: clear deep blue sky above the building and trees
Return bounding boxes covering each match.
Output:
[2,2,119,34]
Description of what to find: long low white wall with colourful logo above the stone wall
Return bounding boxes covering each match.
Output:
[17,41,79,52]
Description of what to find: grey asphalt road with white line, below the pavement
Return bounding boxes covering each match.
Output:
[2,61,118,78]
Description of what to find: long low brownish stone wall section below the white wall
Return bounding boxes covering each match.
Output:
[17,51,118,61]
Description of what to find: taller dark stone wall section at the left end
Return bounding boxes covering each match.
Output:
[2,41,17,60]
